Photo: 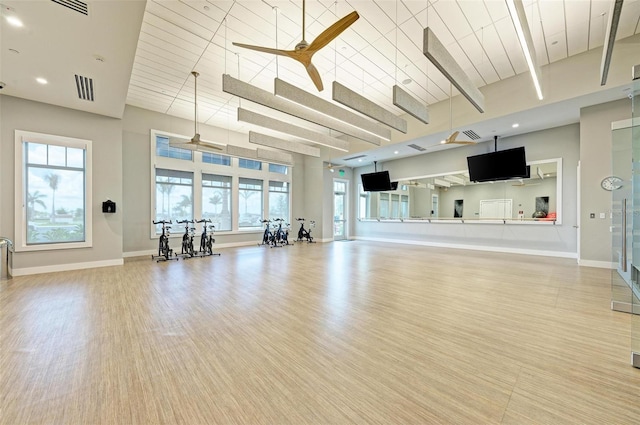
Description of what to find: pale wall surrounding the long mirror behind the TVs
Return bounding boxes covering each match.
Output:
[354,124,580,257]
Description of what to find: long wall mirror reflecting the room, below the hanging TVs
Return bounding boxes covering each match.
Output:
[358,159,562,222]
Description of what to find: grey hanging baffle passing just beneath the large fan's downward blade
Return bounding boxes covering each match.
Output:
[274,78,391,142]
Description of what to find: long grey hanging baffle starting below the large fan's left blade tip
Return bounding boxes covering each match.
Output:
[222,74,380,146]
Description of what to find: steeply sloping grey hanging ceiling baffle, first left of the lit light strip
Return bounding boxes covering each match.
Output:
[422,27,484,112]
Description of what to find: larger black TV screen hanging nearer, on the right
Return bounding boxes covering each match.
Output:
[467,147,527,182]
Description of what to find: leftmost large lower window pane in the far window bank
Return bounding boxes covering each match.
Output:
[155,168,193,234]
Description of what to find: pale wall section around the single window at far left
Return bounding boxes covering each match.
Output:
[0,96,126,275]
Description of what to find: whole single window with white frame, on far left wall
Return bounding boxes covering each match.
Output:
[15,130,91,251]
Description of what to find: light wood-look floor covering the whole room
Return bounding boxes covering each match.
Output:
[0,241,640,425]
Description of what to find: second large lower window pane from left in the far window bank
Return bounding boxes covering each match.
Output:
[202,173,231,230]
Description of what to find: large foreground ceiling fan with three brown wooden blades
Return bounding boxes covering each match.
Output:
[233,0,360,91]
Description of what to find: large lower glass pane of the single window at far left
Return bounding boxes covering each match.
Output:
[26,166,85,245]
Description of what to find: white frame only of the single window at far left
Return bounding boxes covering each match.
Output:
[14,130,93,252]
